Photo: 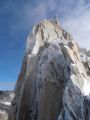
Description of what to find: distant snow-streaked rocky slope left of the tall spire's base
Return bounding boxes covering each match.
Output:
[0,91,14,120]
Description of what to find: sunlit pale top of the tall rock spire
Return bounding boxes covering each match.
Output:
[26,20,72,54]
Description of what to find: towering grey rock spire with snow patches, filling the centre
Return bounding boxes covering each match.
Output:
[8,20,89,120]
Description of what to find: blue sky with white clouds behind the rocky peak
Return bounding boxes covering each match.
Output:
[0,0,90,90]
